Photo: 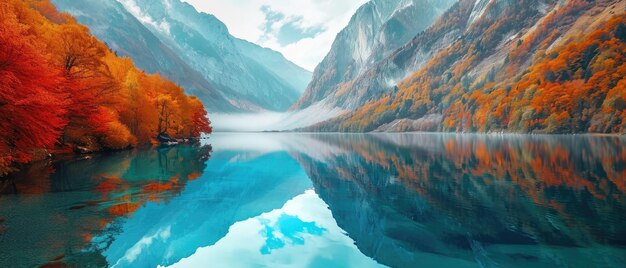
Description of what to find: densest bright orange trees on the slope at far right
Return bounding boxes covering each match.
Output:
[496,15,626,133]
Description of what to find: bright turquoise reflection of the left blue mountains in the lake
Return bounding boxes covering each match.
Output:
[103,150,312,267]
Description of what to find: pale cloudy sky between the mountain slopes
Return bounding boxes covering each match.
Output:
[184,0,367,71]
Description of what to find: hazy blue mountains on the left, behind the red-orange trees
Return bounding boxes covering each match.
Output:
[53,0,310,112]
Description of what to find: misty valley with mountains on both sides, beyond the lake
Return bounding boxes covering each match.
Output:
[53,0,626,133]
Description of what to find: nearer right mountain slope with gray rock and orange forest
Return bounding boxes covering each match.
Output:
[299,0,626,133]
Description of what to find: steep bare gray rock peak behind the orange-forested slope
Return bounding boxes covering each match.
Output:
[292,0,455,110]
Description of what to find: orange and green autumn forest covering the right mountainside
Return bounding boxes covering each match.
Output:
[336,0,626,133]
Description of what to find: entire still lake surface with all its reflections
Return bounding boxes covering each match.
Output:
[0,133,626,267]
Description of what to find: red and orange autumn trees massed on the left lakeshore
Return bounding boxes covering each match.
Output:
[0,0,211,176]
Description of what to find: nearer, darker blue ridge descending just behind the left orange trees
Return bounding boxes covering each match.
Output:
[52,0,236,111]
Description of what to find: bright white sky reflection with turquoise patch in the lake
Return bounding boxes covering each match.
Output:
[168,190,380,267]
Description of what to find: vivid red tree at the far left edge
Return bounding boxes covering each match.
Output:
[0,2,66,176]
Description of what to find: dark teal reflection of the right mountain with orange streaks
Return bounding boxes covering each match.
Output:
[295,134,626,267]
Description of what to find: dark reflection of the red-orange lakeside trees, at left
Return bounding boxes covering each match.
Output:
[0,146,211,267]
